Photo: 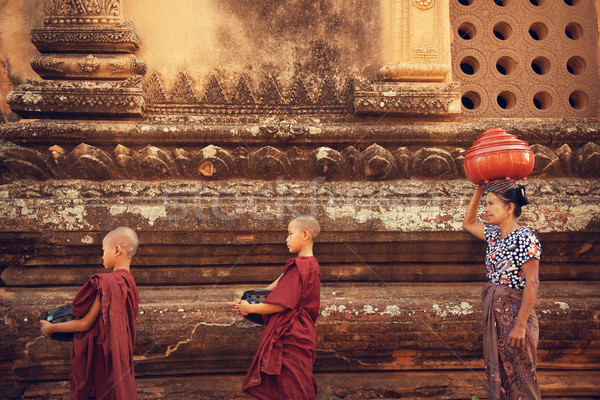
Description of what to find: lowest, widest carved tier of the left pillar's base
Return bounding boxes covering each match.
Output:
[7,75,145,117]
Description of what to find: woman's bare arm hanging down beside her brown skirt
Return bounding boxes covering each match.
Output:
[508,258,540,347]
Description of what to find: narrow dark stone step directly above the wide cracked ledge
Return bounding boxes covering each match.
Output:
[0,257,600,286]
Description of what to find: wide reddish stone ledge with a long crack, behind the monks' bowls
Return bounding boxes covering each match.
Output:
[0,282,600,392]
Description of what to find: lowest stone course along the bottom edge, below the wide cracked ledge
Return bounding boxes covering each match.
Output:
[15,371,598,400]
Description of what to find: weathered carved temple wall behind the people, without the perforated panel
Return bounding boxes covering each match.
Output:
[0,0,600,399]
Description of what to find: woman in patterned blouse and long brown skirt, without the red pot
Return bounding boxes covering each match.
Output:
[463,180,542,400]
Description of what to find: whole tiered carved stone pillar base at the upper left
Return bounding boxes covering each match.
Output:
[7,0,146,117]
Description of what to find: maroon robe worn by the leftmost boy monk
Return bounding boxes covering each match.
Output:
[71,269,140,400]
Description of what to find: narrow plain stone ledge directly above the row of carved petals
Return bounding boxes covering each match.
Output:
[0,121,600,148]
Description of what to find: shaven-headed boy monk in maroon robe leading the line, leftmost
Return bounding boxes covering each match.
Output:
[40,227,140,400]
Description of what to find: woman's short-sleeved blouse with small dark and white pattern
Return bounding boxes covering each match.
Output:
[484,225,542,290]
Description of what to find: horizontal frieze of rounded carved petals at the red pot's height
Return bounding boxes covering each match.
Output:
[0,142,600,181]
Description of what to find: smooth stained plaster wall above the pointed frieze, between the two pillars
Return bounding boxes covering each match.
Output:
[123,0,379,90]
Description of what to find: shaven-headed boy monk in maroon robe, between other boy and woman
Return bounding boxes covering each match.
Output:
[233,215,321,400]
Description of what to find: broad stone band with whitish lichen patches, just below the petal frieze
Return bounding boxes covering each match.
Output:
[0,179,600,234]
